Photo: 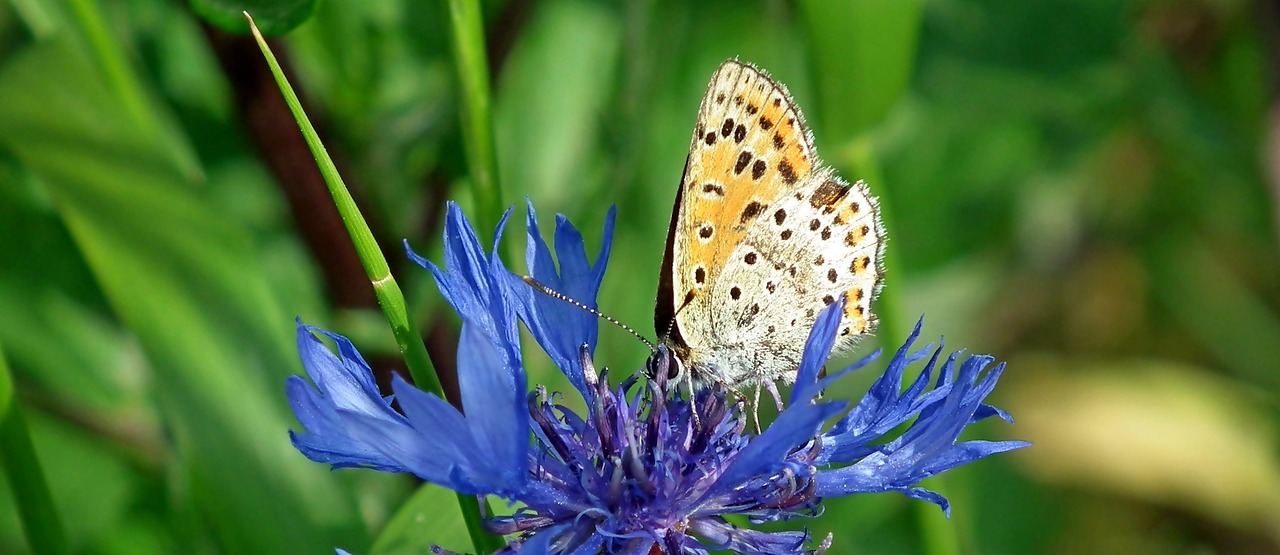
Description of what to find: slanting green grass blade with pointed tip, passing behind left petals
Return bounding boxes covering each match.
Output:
[244,13,503,552]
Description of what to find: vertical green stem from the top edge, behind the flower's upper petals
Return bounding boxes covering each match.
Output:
[448,0,506,233]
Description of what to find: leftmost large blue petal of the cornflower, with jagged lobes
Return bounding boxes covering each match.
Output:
[287,324,529,495]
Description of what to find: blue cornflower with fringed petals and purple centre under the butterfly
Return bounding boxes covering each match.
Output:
[288,205,1028,554]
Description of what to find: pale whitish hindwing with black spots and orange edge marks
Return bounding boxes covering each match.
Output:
[709,169,884,384]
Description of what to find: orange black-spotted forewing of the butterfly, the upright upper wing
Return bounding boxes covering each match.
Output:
[654,60,817,375]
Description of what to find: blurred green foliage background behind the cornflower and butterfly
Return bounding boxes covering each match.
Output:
[0,0,1280,554]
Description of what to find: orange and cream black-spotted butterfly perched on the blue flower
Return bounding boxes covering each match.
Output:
[650,60,884,405]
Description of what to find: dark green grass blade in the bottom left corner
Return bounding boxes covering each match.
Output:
[0,342,68,555]
